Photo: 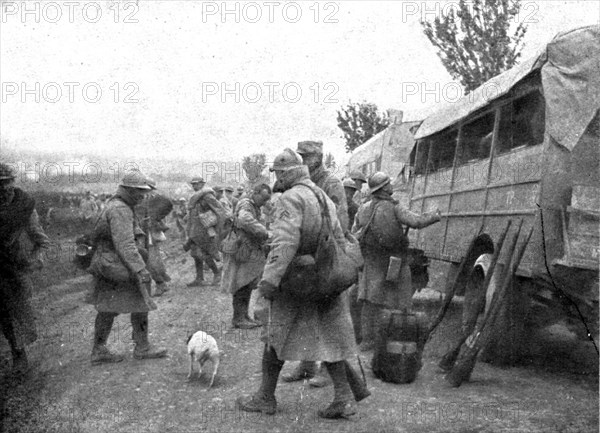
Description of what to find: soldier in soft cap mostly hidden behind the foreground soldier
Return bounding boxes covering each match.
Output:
[281,141,349,388]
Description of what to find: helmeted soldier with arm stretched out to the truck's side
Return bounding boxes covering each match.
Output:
[352,172,441,352]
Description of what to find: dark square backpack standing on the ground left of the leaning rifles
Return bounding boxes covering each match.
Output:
[372,310,428,383]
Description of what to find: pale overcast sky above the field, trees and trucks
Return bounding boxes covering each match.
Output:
[0,0,600,162]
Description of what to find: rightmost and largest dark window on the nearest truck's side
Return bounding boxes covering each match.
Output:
[496,92,546,154]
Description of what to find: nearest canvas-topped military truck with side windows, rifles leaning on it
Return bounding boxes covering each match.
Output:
[409,26,600,362]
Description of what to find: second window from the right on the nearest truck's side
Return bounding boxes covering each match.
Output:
[458,112,495,165]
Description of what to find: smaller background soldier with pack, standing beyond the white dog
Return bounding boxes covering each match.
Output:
[184,176,226,287]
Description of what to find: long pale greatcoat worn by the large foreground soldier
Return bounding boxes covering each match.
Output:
[262,166,356,362]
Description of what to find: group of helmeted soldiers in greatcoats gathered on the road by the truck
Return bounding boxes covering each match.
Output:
[0,141,440,418]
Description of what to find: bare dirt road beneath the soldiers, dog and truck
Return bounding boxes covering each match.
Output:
[0,240,598,433]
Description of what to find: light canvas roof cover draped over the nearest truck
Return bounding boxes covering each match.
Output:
[415,25,600,150]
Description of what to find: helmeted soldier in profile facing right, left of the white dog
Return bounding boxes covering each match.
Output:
[88,171,167,364]
